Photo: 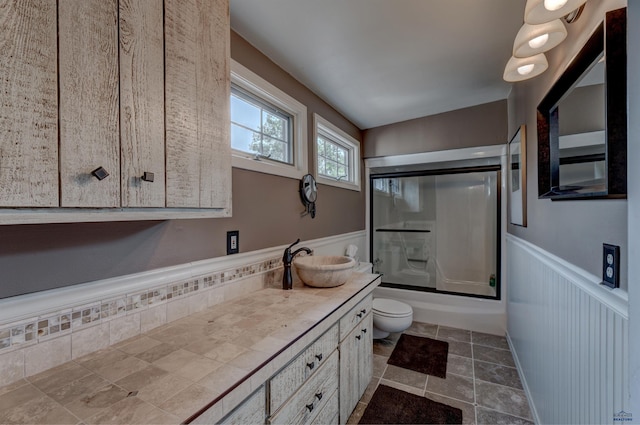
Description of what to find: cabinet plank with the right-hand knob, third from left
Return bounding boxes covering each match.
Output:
[119,0,165,207]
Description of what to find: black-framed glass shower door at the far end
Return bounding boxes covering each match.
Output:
[370,166,501,299]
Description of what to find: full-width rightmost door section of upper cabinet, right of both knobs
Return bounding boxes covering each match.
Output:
[165,0,231,208]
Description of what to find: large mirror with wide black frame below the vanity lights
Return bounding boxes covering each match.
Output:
[538,8,627,200]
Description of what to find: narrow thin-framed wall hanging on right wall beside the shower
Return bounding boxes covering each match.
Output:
[507,124,527,227]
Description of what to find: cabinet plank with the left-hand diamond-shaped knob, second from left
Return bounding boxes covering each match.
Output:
[58,0,120,207]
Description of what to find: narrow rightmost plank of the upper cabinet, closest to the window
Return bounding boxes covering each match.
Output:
[196,0,231,208]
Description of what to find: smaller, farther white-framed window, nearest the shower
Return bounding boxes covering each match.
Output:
[313,114,360,191]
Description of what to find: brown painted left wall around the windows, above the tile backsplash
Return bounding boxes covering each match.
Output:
[0,32,365,298]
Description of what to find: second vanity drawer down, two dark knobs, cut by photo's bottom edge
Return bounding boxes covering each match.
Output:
[269,351,338,424]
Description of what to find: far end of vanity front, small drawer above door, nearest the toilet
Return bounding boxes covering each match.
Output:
[339,295,373,424]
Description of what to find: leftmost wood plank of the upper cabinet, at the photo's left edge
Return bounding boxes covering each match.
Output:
[0,0,58,207]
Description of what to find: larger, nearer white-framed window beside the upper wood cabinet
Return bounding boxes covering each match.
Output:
[231,60,308,179]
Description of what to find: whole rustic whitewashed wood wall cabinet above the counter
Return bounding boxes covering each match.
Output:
[0,0,231,224]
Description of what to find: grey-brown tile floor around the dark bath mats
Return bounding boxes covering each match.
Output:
[348,322,533,425]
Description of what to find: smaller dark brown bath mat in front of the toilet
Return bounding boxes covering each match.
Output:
[387,334,449,378]
